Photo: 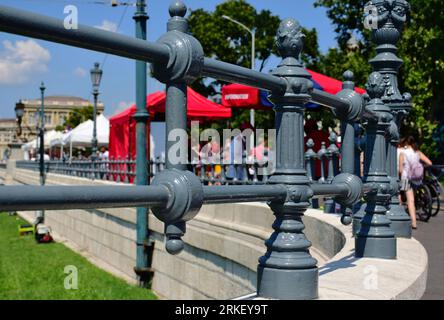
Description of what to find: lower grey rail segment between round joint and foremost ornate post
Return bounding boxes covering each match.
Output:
[203,185,287,204]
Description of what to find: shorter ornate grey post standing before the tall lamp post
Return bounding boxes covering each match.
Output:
[355,72,396,259]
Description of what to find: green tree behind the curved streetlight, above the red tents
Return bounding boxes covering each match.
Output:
[189,0,320,129]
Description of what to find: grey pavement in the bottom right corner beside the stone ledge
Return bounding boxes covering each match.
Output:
[413,209,444,300]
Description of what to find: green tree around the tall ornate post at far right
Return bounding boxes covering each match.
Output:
[315,0,444,158]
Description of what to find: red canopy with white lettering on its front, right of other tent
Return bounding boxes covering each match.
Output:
[222,69,365,109]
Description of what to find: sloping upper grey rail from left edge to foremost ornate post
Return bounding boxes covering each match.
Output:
[0,6,287,93]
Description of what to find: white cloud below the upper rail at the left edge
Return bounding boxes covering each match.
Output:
[0,39,51,85]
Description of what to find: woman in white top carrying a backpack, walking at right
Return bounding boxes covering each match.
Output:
[399,136,432,229]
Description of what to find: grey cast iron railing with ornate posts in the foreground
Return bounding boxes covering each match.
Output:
[0,0,411,299]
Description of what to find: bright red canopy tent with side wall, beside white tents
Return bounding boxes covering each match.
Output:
[109,88,231,159]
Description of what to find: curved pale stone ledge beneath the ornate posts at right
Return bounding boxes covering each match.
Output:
[236,210,428,300]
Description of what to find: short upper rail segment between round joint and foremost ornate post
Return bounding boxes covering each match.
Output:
[202,58,287,93]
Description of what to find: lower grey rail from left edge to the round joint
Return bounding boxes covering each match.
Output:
[0,186,170,211]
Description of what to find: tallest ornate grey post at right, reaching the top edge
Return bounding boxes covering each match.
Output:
[370,0,412,238]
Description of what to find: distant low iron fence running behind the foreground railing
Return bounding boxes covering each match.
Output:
[15,140,348,185]
